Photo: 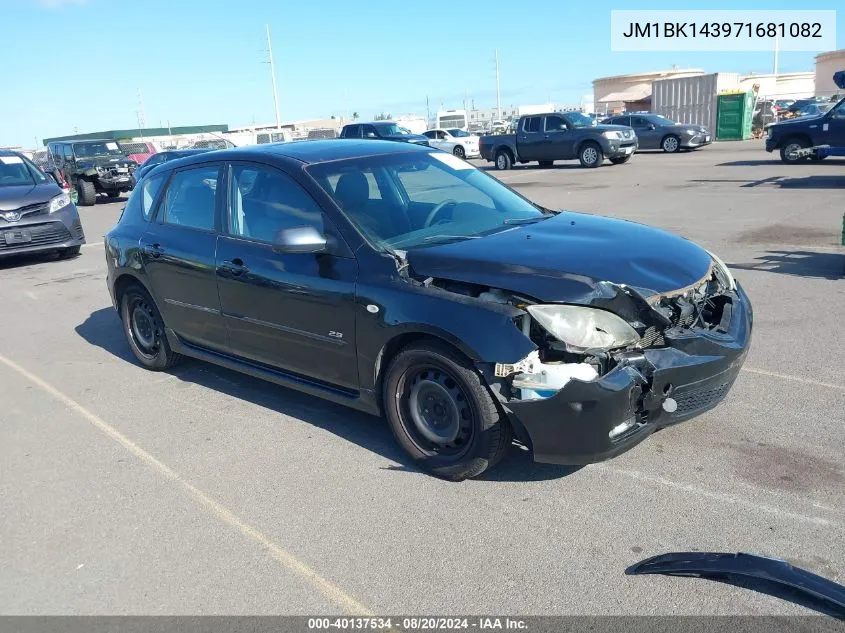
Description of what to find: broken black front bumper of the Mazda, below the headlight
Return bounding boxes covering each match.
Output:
[503,287,753,465]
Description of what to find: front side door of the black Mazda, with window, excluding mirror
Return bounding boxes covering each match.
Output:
[215,162,359,390]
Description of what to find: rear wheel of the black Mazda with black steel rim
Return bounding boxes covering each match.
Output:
[120,284,181,371]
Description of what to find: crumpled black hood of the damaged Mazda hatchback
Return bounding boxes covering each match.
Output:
[407,211,712,303]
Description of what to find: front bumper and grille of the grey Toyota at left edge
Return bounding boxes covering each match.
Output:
[0,204,85,257]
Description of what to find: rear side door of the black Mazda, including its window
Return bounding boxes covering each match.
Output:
[139,163,228,351]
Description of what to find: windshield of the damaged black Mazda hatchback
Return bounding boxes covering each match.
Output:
[308,152,549,250]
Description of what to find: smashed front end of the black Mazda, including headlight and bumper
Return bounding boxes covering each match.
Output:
[436,257,752,464]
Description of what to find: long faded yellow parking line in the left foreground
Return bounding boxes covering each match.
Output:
[0,355,373,616]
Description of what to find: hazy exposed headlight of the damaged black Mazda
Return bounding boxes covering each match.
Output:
[528,305,640,353]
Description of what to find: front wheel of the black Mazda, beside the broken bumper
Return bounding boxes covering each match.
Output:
[382,341,513,481]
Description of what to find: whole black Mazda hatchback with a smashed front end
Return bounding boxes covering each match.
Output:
[105,140,752,480]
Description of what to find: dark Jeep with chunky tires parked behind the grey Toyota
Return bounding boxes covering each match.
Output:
[47,140,138,206]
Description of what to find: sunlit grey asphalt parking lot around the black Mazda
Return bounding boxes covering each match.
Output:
[0,141,845,615]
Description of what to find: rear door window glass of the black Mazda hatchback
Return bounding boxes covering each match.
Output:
[158,165,220,231]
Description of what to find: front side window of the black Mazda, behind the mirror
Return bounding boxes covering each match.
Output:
[227,165,325,243]
